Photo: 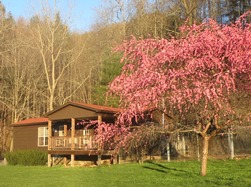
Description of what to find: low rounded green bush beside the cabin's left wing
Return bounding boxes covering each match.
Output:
[5,150,47,166]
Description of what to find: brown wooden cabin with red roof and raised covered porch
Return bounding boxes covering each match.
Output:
[13,102,120,166]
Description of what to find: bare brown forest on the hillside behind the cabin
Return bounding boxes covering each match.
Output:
[0,0,251,155]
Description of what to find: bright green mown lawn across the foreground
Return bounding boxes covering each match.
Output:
[0,159,251,187]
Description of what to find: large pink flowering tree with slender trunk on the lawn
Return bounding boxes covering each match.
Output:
[110,14,251,176]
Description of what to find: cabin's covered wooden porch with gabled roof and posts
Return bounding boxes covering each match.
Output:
[46,102,120,167]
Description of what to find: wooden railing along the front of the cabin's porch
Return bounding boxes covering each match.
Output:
[51,135,98,150]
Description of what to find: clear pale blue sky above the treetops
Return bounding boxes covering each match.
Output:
[1,0,102,32]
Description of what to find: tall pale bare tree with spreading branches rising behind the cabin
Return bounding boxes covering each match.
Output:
[30,1,85,110]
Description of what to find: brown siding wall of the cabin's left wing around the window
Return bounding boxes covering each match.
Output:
[13,124,48,152]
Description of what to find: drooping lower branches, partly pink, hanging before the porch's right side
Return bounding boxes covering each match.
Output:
[81,120,171,162]
